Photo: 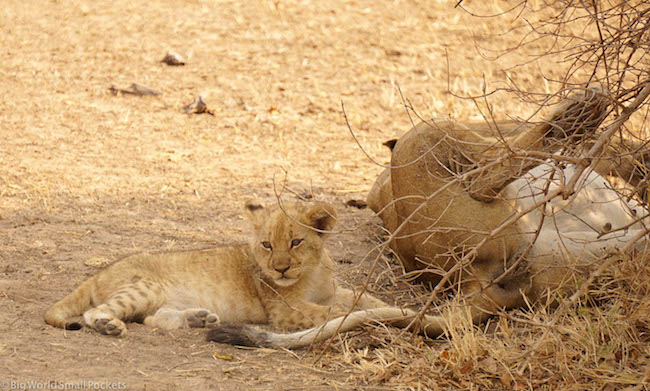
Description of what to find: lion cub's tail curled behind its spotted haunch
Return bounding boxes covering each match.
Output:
[45,278,94,330]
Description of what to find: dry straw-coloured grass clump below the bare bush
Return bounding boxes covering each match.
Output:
[305,243,650,390]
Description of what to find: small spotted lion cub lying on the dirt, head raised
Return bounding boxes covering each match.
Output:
[45,202,385,337]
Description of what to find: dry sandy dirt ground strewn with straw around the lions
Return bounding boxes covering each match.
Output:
[0,0,644,390]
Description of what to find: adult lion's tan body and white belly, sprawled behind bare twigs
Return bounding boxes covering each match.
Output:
[368,88,648,332]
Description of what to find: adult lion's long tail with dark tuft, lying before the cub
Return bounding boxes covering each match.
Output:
[207,307,443,349]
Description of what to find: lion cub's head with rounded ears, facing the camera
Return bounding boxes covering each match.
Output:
[244,201,336,286]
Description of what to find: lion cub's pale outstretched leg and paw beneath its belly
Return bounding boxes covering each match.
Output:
[144,307,219,330]
